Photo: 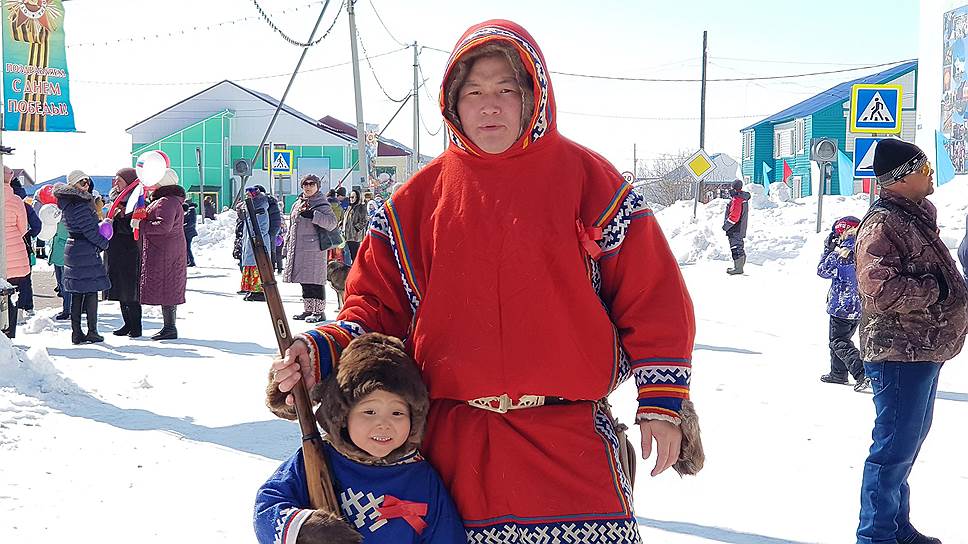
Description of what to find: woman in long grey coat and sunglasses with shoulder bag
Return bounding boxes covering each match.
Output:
[282,174,336,323]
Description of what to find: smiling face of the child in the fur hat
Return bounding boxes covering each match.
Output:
[347,390,410,458]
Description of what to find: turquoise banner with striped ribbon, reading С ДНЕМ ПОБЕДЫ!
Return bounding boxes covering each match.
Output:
[3,0,75,132]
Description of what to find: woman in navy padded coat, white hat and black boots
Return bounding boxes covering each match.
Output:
[54,170,111,344]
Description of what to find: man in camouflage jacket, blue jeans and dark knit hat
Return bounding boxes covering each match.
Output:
[856,138,968,544]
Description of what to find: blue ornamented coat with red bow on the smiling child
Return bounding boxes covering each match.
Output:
[254,443,467,544]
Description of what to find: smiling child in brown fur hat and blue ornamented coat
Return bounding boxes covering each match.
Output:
[254,333,467,544]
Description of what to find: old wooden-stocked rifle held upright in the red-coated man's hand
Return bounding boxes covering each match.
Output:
[245,195,341,515]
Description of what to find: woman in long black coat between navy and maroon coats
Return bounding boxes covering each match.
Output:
[107,168,141,338]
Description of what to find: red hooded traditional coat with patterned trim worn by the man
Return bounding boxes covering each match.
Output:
[305,21,695,542]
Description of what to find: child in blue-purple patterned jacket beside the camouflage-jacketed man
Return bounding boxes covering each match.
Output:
[817,215,870,391]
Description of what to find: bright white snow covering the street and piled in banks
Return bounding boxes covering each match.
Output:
[0,179,968,544]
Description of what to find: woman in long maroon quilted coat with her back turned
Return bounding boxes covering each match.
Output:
[140,168,188,340]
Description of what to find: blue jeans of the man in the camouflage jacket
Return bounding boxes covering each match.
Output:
[857,362,942,544]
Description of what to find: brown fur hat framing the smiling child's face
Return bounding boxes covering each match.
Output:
[310,333,430,464]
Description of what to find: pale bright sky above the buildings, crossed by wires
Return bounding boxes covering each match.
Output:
[5,0,919,183]
